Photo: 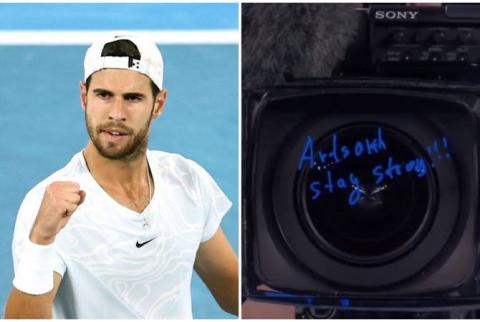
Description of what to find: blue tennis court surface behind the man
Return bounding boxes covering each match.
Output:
[0,4,238,318]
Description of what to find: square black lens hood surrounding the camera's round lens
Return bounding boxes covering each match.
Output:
[242,78,480,310]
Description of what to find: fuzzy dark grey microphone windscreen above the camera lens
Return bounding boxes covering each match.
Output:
[242,3,360,89]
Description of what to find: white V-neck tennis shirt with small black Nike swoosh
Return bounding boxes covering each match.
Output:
[12,151,231,319]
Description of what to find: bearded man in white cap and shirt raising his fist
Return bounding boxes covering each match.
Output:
[6,35,238,318]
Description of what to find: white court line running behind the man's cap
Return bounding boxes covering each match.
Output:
[0,30,240,45]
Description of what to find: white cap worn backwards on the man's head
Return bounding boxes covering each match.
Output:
[84,34,163,89]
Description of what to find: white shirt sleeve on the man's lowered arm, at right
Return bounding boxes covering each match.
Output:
[188,162,232,242]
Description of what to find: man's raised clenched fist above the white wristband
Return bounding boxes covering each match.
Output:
[30,181,85,245]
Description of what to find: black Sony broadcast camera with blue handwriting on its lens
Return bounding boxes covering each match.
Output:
[242,4,480,318]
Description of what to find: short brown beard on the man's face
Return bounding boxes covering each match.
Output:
[85,107,153,161]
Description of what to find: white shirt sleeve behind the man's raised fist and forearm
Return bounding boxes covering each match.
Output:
[12,188,66,276]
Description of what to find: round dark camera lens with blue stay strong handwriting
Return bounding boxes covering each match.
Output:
[295,124,437,265]
